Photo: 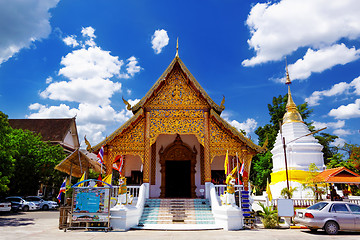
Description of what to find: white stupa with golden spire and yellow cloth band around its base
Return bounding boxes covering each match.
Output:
[270,68,325,199]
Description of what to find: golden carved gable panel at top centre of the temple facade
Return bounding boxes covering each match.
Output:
[145,65,210,144]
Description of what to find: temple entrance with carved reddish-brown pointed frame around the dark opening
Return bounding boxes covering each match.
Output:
[159,134,197,198]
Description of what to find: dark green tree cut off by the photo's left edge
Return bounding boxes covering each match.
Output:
[0,111,15,194]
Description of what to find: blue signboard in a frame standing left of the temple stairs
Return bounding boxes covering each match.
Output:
[72,187,109,222]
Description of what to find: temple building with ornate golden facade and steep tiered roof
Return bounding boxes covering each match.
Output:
[91,45,265,198]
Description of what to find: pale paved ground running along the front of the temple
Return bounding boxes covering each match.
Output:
[0,211,360,240]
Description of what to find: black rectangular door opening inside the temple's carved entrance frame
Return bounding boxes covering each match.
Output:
[165,160,191,198]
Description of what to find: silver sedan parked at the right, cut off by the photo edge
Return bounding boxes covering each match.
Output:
[294,201,360,234]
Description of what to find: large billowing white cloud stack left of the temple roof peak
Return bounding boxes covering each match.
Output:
[27,27,142,144]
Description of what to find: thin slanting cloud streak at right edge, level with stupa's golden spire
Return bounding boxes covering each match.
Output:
[305,77,360,106]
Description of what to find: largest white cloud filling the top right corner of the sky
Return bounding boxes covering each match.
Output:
[242,0,360,67]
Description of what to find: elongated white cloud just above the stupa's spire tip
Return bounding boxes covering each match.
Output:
[289,44,360,80]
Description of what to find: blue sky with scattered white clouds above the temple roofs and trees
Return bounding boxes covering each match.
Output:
[0,0,360,148]
